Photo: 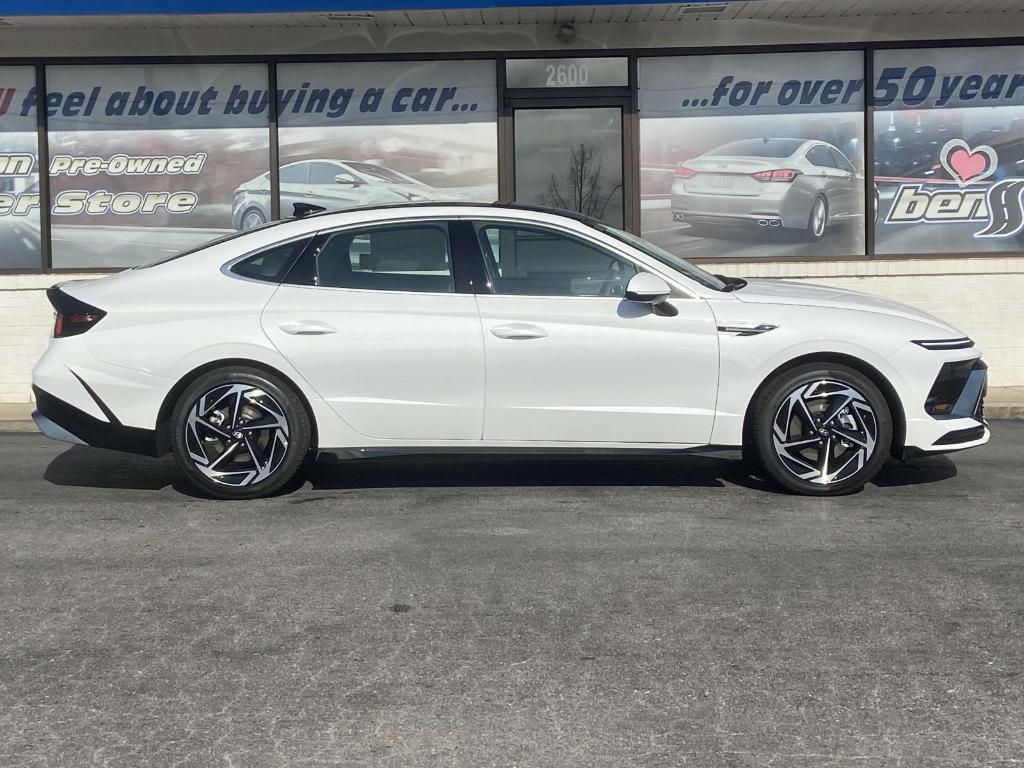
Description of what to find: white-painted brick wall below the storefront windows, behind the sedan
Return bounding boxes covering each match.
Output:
[0,256,1024,402]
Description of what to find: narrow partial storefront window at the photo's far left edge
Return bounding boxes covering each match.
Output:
[0,67,42,269]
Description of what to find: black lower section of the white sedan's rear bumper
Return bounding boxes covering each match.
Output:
[32,386,158,456]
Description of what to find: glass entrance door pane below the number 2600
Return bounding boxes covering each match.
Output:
[512,106,624,227]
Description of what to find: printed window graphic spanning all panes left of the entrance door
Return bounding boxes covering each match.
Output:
[0,60,498,267]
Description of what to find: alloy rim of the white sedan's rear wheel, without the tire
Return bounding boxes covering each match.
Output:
[184,383,289,487]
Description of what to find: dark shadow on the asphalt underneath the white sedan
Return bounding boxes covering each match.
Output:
[43,445,956,496]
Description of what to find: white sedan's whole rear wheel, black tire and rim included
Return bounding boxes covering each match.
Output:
[171,367,312,500]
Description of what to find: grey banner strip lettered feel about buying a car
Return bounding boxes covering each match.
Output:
[0,61,497,130]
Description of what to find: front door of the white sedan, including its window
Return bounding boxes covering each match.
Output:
[474,221,718,444]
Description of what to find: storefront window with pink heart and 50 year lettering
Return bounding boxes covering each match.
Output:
[874,46,1024,254]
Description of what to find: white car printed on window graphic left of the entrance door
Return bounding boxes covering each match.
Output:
[231,159,466,230]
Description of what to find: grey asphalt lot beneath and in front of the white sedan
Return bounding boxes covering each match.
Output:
[0,428,1024,768]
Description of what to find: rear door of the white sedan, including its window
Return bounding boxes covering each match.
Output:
[262,220,483,442]
